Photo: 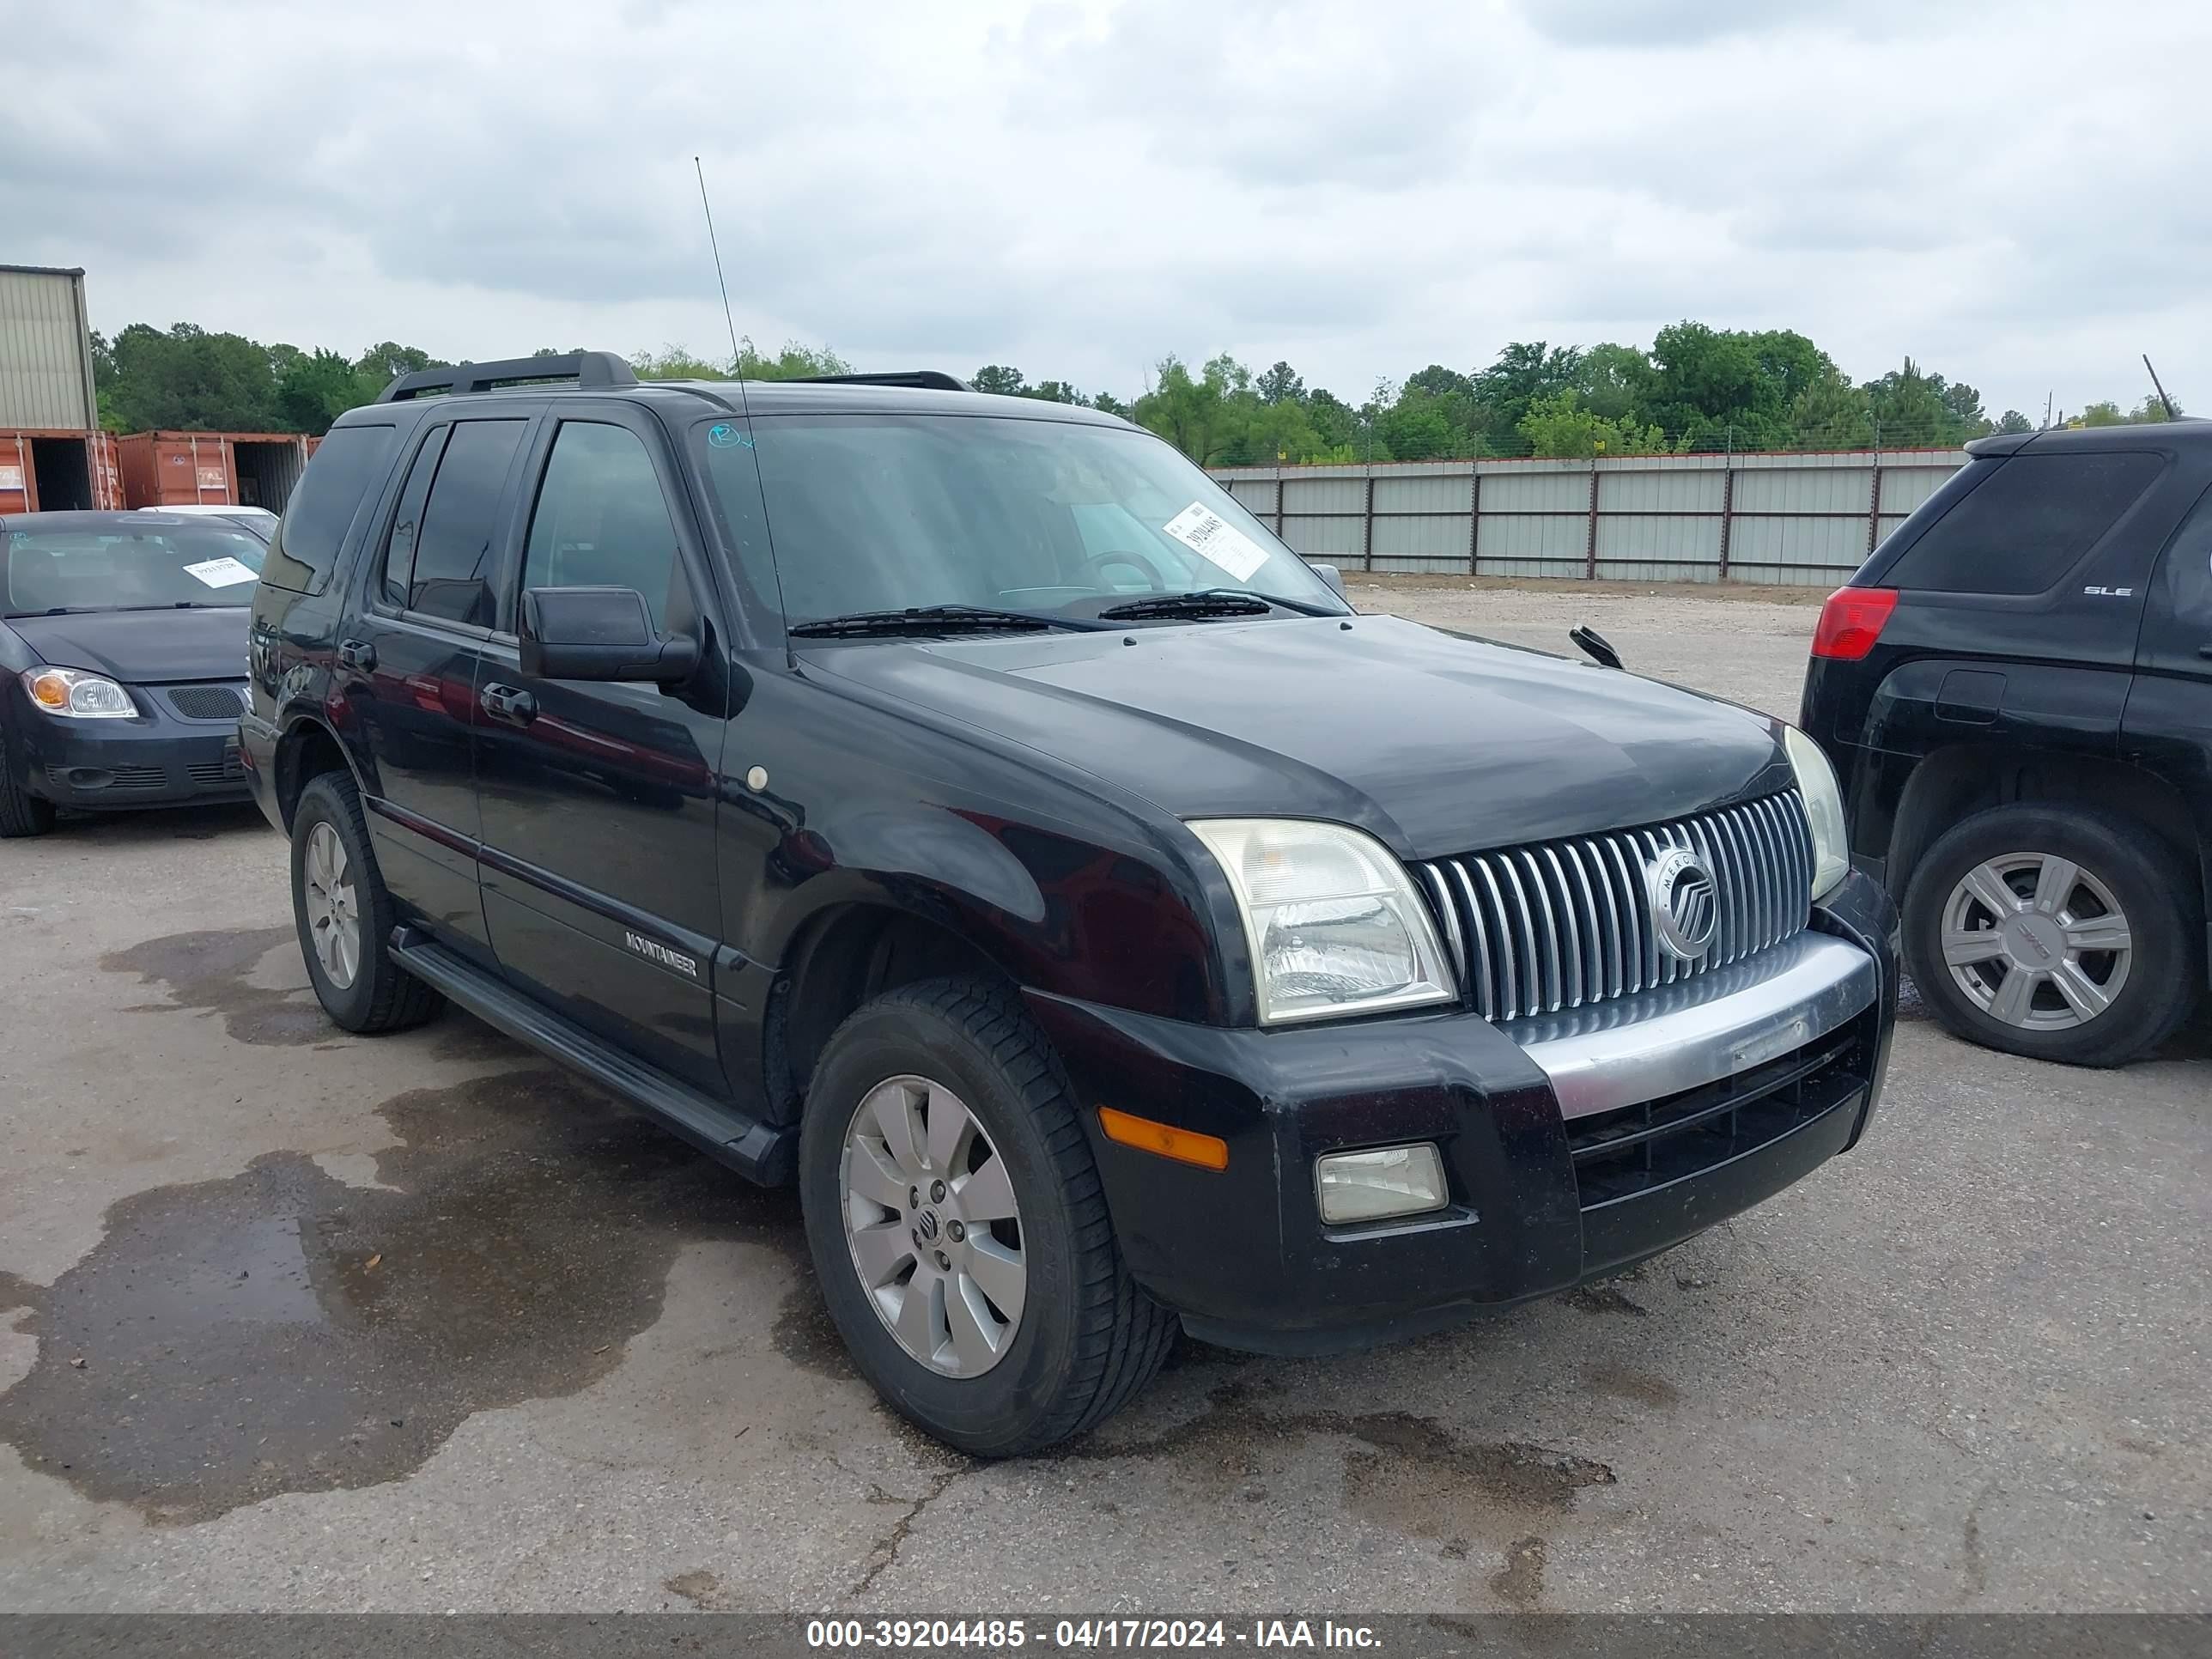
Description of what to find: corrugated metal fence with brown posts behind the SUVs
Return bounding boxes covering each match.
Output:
[1212,449,1966,586]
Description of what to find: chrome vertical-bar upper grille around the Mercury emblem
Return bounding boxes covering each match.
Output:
[1416,790,1812,1020]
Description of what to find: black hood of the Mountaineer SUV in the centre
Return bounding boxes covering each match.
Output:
[803,617,1790,858]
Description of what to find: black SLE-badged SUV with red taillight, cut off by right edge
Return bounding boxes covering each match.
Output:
[1802,420,2212,1066]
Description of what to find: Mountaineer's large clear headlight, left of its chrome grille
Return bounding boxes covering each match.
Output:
[1190,818,1455,1024]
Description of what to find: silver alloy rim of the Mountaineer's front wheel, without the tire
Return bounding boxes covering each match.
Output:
[838,1078,1029,1378]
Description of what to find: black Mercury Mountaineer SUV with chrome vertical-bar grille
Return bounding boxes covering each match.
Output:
[241,354,1896,1455]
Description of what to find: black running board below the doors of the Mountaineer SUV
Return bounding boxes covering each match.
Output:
[392,927,799,1186]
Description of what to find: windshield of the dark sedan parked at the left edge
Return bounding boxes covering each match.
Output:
[0,520,268,617]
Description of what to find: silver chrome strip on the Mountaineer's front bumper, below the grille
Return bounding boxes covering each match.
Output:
[1500,929,1881,1117]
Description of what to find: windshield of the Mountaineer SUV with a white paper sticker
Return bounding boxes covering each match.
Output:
[695,414,1345,626]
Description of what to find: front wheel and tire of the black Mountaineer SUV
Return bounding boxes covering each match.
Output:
[799,980,1176,1458]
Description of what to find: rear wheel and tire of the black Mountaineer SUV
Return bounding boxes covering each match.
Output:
[292,772,445,1036]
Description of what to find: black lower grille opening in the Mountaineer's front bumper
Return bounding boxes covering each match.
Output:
[1566,1030,1867,1210]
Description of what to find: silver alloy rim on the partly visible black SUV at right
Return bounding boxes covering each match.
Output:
[1942,852,2135,1030]
